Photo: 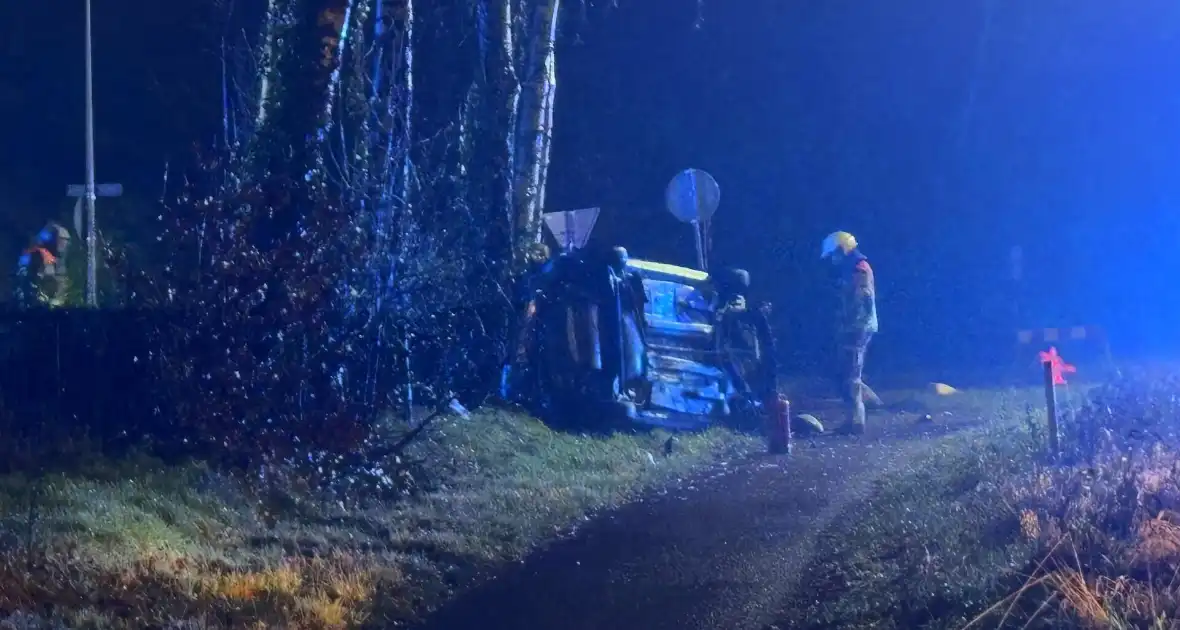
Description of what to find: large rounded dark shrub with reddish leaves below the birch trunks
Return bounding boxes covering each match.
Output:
[139,168,503,490]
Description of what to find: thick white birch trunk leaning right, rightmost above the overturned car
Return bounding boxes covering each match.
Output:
[514,0,561,259]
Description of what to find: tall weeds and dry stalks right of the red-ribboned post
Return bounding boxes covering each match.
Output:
[1005,376,1180,628]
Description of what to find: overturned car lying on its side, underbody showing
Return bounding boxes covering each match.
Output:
[504,248,778,429]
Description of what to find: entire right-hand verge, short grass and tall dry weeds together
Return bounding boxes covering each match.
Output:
[773,381,1180,630]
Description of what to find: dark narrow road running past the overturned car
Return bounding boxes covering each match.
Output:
[405,416,974,630]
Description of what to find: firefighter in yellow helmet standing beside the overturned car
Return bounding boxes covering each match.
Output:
[820,231,877,434]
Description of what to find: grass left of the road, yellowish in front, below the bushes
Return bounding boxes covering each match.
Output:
[0,411,754,630]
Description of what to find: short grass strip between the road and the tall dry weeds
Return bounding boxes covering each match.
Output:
[773,392,1052,630]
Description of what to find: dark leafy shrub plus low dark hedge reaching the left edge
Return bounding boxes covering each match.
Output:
[0,145,510,502]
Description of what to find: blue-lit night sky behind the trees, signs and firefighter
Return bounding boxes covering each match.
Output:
[0,0,1180,375]
